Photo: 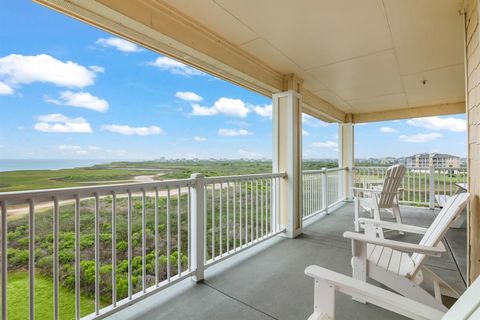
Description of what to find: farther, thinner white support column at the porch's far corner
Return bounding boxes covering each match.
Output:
[338,123,355,200]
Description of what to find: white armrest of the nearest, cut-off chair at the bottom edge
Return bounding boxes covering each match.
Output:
[305,265,445,320]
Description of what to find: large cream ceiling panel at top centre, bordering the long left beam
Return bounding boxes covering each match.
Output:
[216,0,392,69]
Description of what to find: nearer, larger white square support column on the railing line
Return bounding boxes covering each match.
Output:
[272,90,303,238]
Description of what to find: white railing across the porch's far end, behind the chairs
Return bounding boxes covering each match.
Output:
[354,167,467,208]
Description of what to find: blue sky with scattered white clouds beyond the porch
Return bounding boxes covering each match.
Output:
[0,0,466,160]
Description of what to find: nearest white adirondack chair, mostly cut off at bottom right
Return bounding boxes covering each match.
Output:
[305,265,480,320]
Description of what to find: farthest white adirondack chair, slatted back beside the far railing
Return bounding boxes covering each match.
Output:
[353,164,406,238]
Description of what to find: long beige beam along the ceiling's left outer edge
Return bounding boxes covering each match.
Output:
[34,0,345,122]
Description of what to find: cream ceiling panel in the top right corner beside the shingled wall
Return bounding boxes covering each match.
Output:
[384,0,463,75]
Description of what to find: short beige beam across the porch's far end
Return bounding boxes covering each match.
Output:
[352,102,466,123]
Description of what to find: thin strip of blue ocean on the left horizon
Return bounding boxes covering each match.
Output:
[0,159,111,172]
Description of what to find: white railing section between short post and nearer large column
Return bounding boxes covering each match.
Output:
[205,174,284,268]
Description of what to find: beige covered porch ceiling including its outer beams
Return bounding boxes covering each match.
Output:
[36,0,465,123]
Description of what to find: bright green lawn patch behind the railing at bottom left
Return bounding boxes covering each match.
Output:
[8,271,95,320]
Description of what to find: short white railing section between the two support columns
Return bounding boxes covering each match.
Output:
[302,168,347,219]
